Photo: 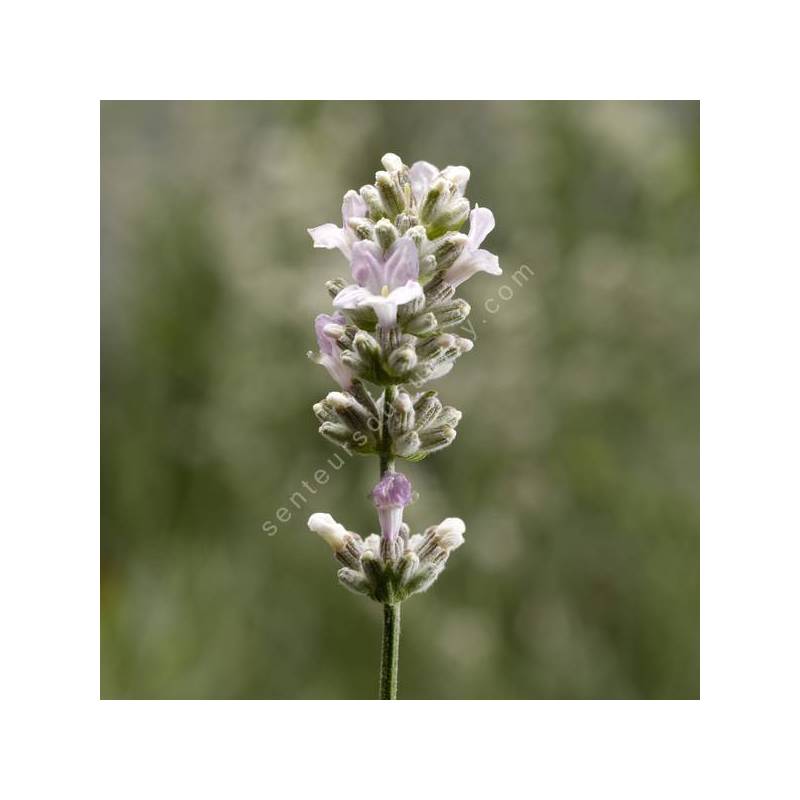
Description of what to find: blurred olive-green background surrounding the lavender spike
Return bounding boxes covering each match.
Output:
[101,102,699,698]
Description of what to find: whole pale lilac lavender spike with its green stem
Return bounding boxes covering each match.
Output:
[308,153,501,700]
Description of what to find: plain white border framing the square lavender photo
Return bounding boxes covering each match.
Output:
[0,0,800,798]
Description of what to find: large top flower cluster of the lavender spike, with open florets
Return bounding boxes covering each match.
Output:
[308,153,501,400]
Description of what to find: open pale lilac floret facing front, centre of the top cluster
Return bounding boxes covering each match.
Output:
[333,238,423,328]
